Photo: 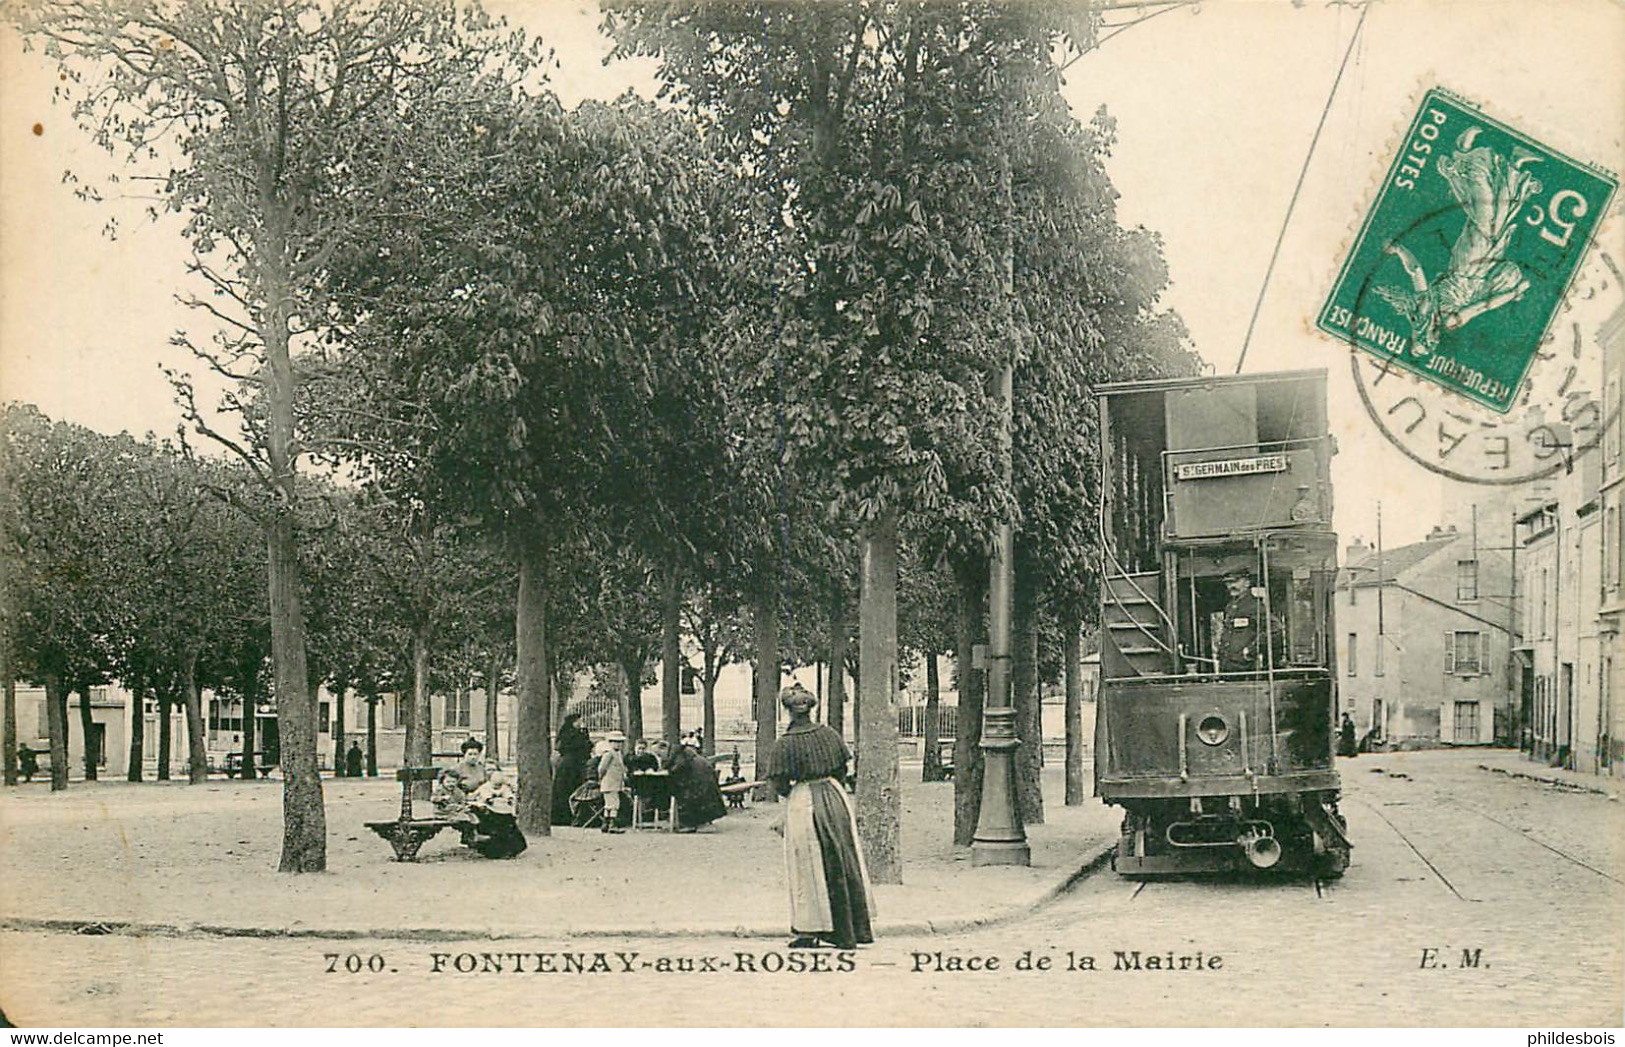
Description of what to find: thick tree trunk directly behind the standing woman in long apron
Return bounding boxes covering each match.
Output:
[858,512,904,883]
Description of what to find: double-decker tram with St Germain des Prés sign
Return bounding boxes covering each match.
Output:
[1095,371,1350,876]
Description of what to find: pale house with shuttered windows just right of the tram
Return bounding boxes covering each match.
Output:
[1337,527,1513,746]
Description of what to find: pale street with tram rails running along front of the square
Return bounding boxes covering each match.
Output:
[0,753,1625,1026]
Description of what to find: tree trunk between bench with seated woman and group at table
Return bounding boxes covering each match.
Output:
[514,533,553,836]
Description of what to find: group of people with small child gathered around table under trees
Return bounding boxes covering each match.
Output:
[553,712,726,832]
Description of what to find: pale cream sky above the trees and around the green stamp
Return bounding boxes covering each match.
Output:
[0,0,1625,546]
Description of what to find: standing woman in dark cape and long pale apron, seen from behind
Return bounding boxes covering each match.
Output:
[765,683,874,949]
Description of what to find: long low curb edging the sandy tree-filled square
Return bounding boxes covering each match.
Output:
[0,841,1116,941]
